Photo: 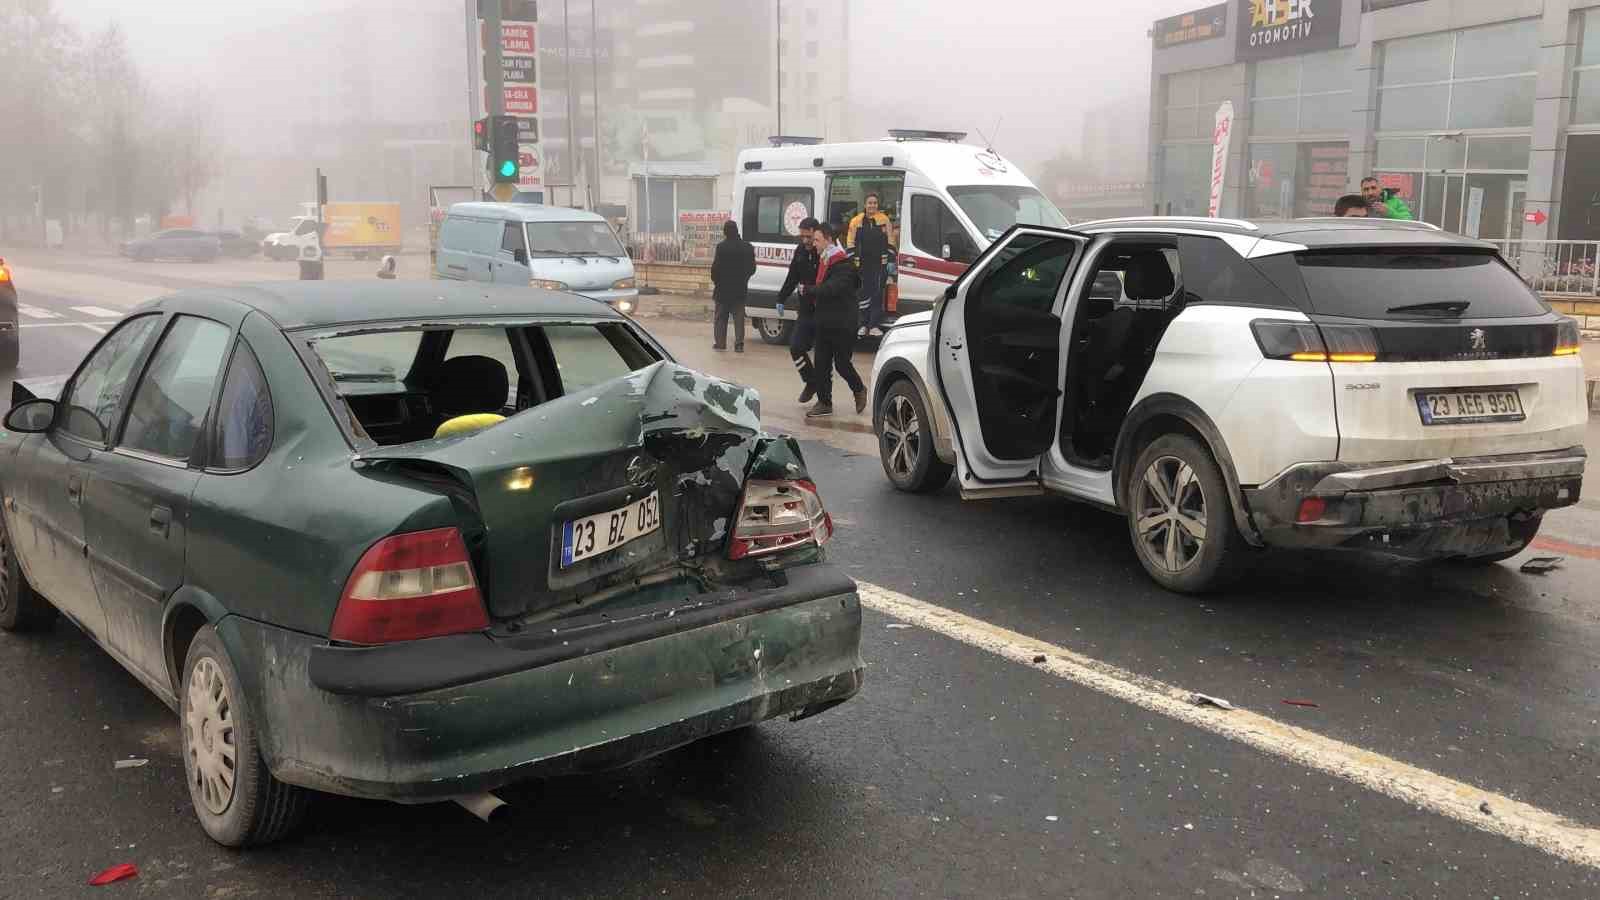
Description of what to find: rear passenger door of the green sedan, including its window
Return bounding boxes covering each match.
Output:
[83,315,230,687]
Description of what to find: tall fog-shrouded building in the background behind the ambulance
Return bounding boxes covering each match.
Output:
[539,0,850,234]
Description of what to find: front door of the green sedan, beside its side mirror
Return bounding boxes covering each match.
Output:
[11,315,162,630]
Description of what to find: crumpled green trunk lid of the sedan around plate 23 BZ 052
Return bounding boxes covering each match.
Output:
[357,362,768,618]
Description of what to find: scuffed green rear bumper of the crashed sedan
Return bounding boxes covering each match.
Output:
[222,564,864,802]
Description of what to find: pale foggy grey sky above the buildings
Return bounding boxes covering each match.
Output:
[58,0,1206,168]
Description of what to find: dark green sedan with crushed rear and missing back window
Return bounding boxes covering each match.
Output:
[0,282,862,846]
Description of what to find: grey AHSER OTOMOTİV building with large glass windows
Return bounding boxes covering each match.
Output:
[1149,0,1600,240]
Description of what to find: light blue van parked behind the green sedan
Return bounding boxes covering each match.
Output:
[434,203,638,312]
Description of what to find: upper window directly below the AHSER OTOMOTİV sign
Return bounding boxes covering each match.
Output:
[1250,50,1354,136]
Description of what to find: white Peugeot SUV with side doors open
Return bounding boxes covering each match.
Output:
[872,218,1587,593]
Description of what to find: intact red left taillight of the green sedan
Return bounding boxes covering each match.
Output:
[328,528,490,644]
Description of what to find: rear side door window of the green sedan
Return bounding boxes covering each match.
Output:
[122,315,229,461]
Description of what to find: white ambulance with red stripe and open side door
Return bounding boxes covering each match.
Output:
[733,130,1069,344]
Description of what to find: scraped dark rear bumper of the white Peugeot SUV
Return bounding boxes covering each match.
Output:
[1245,447,1586,557]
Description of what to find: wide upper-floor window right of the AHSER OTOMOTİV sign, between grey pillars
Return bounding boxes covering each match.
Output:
[1378,19,1539,131]
